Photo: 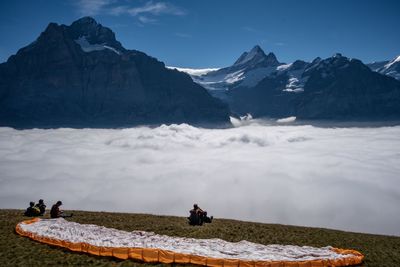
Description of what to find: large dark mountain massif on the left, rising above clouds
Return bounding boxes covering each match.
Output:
[0,17,229,128]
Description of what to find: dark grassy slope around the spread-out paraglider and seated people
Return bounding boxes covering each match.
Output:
[0,210,400,267]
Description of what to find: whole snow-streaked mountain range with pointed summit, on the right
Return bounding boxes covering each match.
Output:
[174,46,400,120]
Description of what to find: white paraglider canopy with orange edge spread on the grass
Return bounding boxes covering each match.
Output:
[16,218,364,267]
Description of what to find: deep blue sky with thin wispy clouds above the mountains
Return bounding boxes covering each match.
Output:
[0,0,400,68]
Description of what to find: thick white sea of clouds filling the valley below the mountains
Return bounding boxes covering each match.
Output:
[0,123,400,235]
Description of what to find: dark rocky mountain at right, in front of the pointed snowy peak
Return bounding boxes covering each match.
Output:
[229,54,400,120]
